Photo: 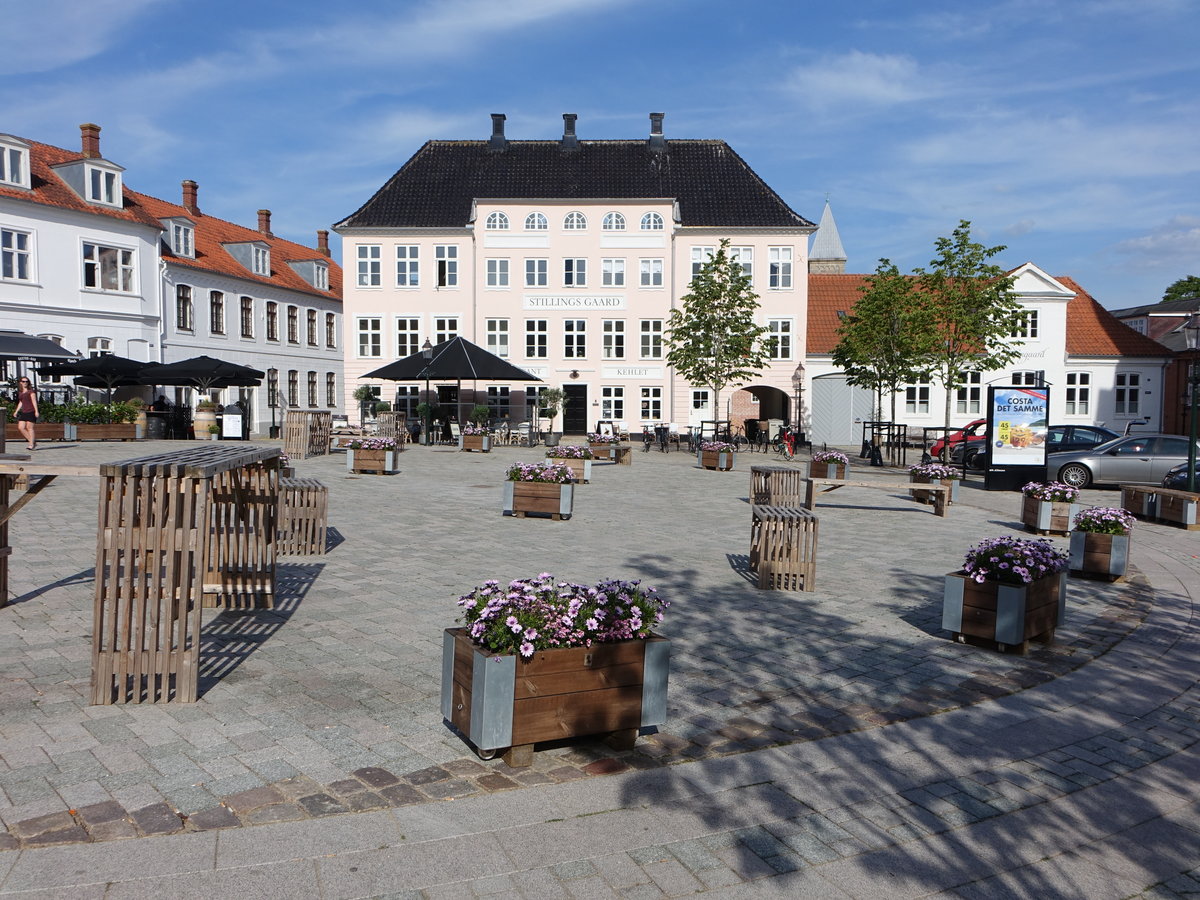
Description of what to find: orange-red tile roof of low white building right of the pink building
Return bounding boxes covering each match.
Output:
[808,275,1170,356]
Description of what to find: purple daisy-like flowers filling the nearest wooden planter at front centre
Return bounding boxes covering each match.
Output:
[458,572,670,659]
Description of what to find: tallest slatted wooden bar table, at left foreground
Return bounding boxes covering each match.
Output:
[91,443,280,706]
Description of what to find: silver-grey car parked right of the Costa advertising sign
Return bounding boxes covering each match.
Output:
[1046,434,1188,487]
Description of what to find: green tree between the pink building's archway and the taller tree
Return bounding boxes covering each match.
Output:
[833,259,924,421]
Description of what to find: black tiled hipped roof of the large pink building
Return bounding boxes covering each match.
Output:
[338,140,812,228]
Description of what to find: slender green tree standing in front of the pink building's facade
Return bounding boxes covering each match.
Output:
[664,239,772,418]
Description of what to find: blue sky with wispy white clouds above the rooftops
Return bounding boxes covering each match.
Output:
[0,0,1200,308]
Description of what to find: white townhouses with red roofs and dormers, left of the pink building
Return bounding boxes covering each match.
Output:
[0,125,344,433]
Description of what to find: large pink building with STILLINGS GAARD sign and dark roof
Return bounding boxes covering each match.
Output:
[335,113,815,433]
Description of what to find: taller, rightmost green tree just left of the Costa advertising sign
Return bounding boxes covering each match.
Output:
[913,220,1022,448]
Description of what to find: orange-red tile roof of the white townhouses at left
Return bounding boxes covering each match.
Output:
[0,138,342,302]
